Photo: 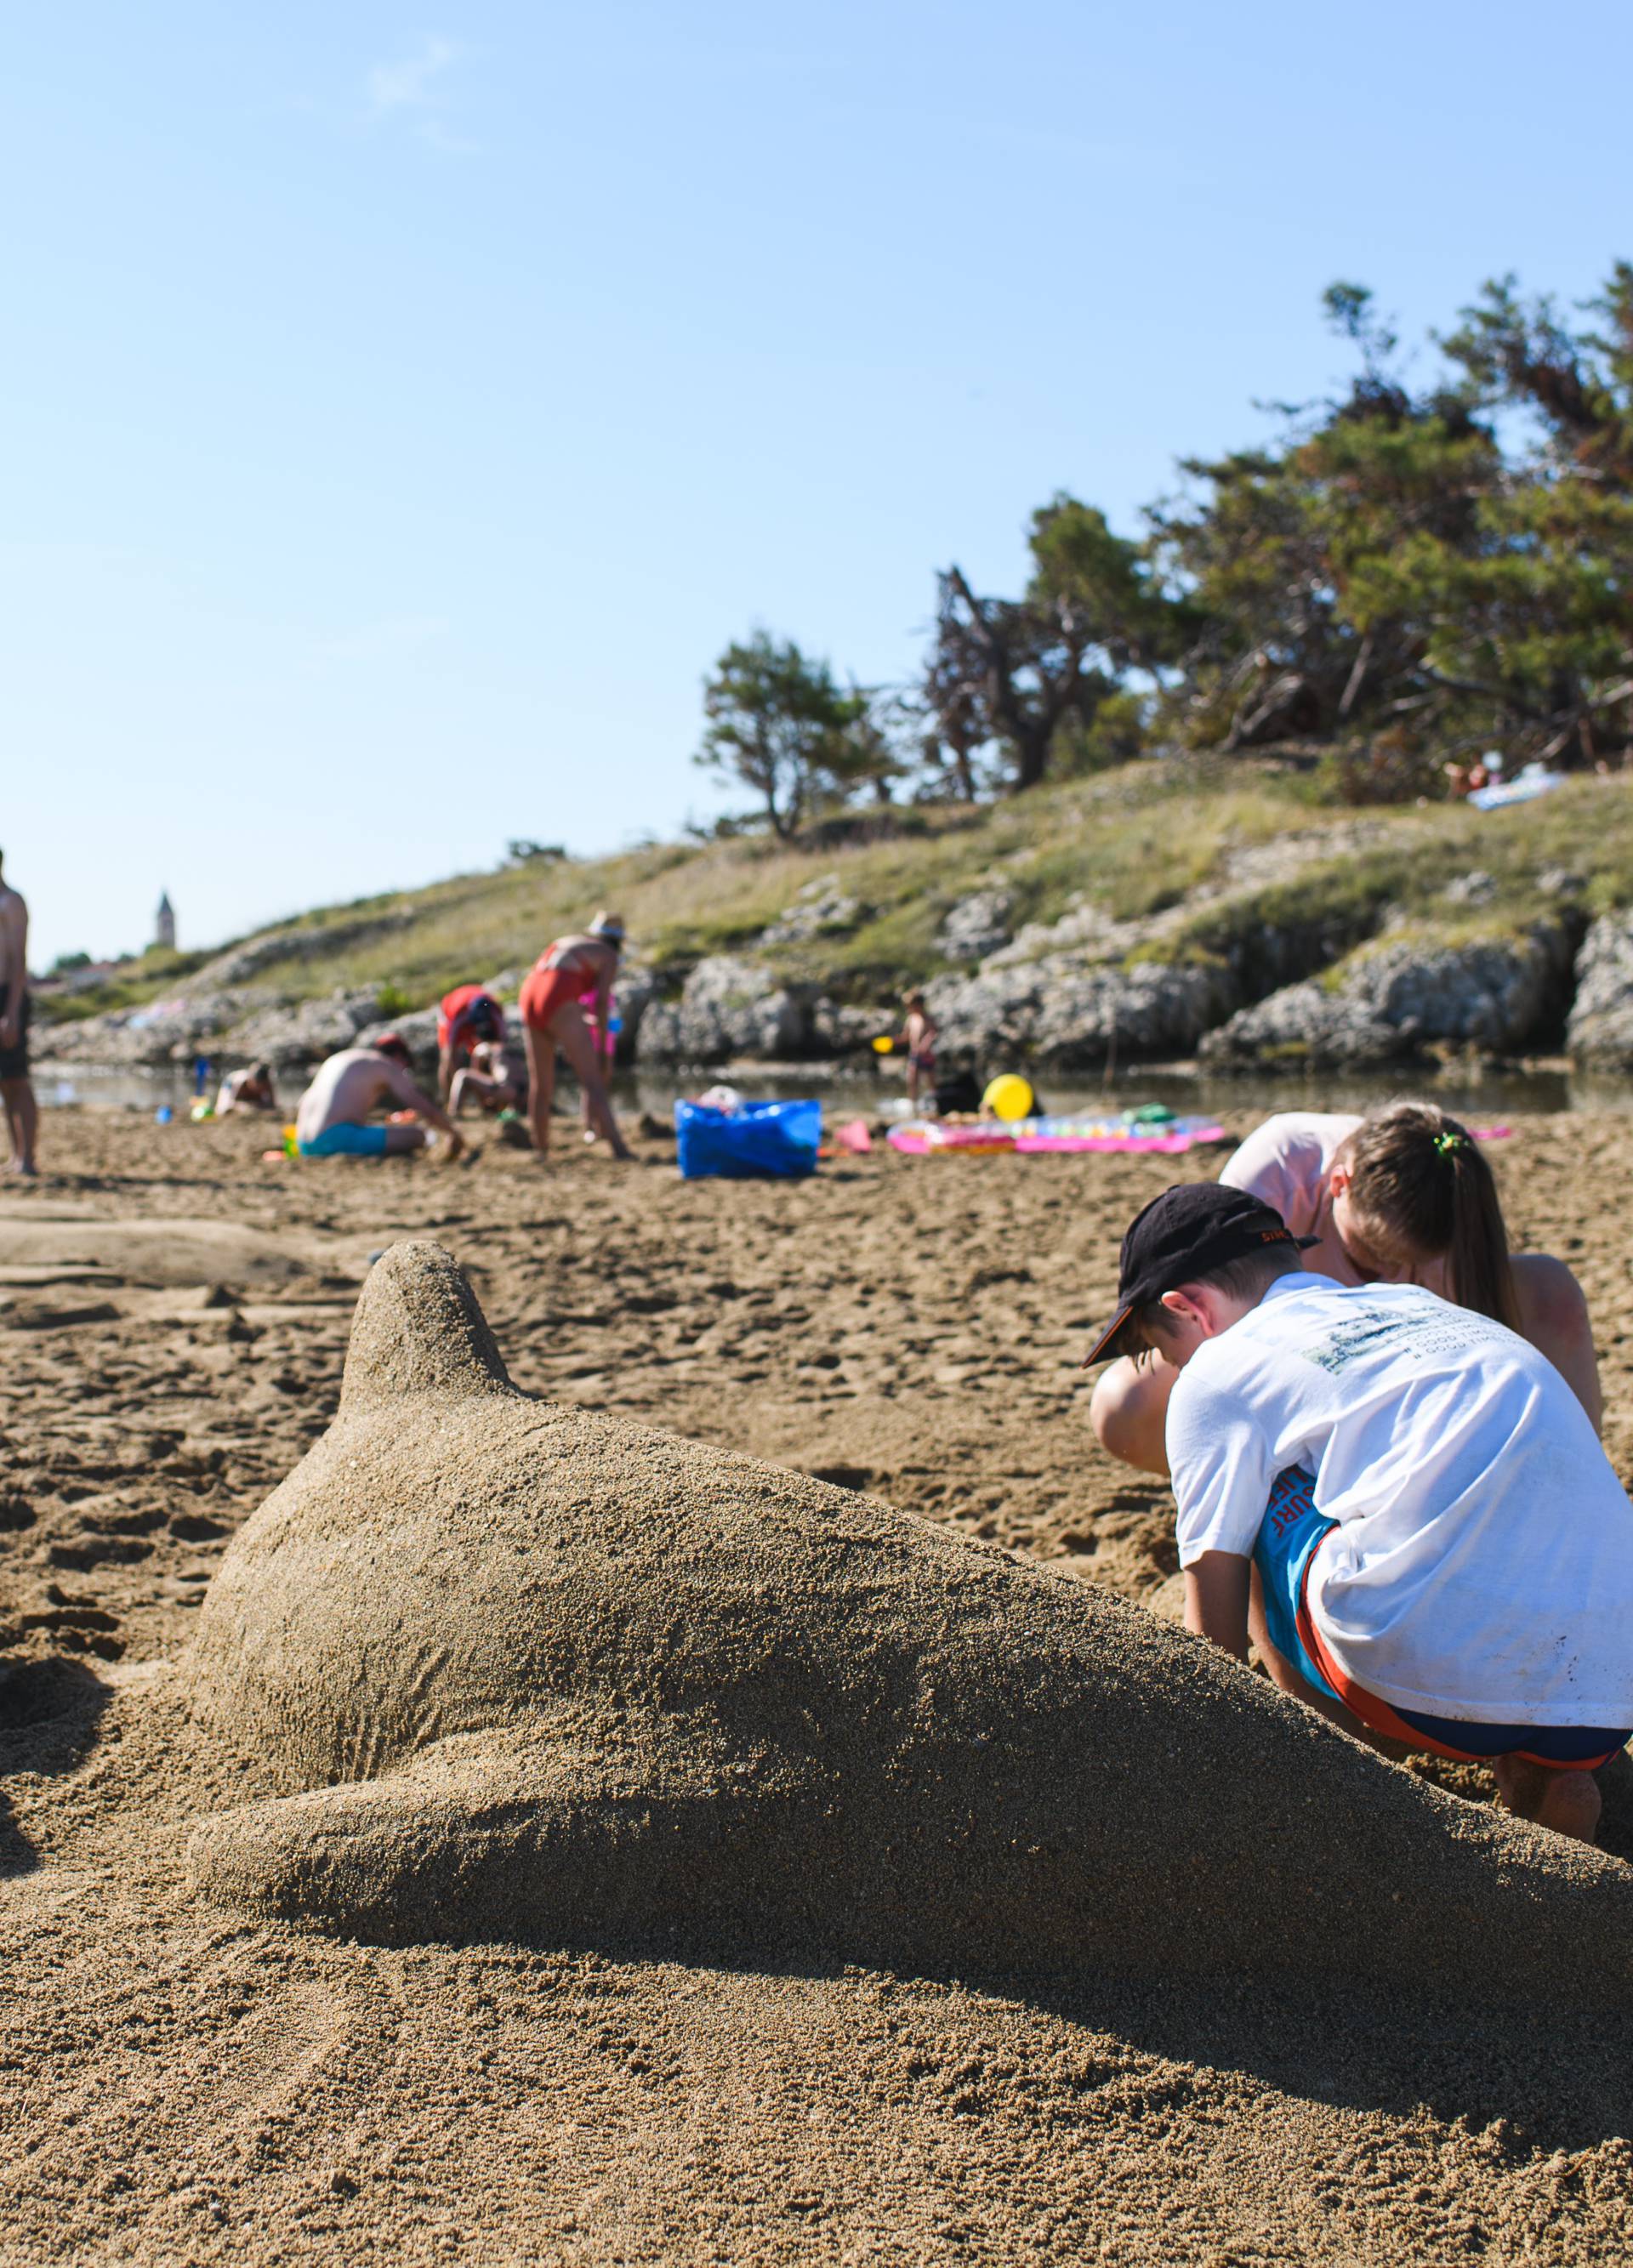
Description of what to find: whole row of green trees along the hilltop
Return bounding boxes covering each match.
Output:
[701,263,1633,834]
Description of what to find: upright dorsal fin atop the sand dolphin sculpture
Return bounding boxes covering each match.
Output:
[340,1238,515,1415]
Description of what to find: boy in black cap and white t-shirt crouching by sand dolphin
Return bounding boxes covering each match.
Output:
[1089,1182,1633,1842]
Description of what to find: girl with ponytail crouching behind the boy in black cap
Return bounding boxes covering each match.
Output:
[1089,1102,1603,1472]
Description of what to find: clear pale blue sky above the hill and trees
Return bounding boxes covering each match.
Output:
[0,0,1633,963]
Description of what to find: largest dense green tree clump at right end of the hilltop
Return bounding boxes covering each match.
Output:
[1152,265,1633,792]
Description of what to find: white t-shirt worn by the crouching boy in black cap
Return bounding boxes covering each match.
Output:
[1168,1272,1633,1731]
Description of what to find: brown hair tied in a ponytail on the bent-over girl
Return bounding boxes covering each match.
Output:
[1343,1102,1520,1332]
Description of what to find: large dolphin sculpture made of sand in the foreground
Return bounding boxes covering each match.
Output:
[191,1243,1633,2000]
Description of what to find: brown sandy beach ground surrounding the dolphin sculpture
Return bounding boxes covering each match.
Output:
[0,1109,1633,2264]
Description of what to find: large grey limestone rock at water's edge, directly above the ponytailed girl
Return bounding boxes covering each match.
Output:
[1200,923,1569,1066]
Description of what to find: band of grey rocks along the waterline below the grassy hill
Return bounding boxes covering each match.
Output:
[37,866,1633,1075]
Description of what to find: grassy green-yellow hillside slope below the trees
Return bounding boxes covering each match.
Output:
[41,759,1633,1016]
